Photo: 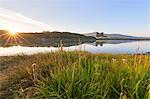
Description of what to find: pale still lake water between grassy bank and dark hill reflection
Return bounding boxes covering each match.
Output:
[0,41,150,56]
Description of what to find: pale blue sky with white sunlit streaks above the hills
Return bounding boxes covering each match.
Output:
[0,0,150,37]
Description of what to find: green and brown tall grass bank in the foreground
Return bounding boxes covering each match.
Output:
[0,51,150,99]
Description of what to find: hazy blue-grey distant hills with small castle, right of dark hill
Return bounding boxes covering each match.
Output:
[84,32,150,40]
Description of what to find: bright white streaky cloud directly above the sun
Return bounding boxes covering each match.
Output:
[0,8,51,32]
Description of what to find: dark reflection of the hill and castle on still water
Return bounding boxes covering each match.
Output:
[0,39,144,47]
